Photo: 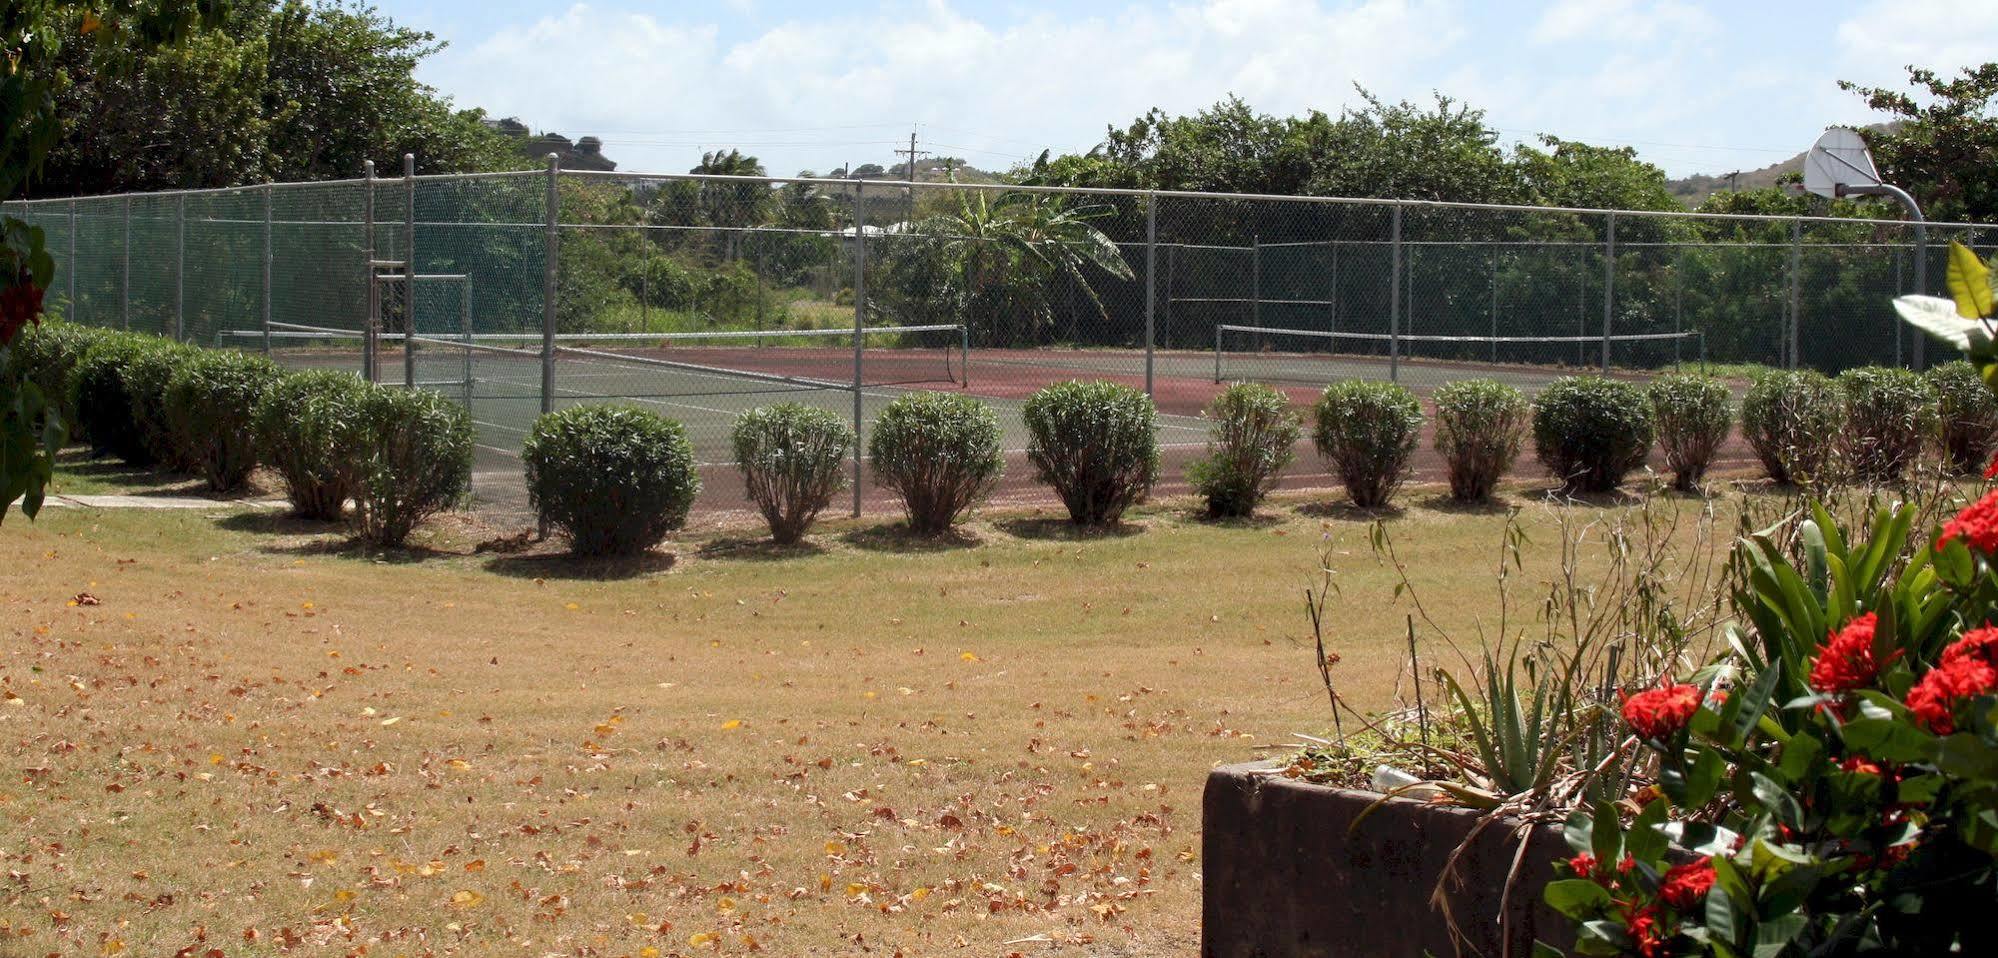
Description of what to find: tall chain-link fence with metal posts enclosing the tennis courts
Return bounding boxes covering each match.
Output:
[8,170,1998,524]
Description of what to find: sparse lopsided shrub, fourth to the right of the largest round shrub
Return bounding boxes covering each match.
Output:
[1187,382,1305,518]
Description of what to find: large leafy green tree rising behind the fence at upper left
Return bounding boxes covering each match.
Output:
[40,0,521,194]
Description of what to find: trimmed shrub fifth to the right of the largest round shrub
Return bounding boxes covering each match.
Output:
[1311,380,1423,508]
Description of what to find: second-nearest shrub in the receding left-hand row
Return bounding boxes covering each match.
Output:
[252,370,368,520]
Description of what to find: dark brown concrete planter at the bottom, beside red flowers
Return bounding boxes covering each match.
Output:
[1201,764,1574,958]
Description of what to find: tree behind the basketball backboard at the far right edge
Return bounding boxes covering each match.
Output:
[1838,62,1998,222]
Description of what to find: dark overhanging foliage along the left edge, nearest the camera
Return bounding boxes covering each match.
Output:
[0,0,228,520]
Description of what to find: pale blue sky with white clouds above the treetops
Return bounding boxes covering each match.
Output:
[389,0,1998,176]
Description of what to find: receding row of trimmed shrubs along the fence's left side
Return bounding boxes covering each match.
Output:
[12,324,472,546]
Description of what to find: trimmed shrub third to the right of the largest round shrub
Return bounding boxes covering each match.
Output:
[1021,382,1159,526]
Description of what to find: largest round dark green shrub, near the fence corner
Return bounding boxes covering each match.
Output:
[521,404,701,556]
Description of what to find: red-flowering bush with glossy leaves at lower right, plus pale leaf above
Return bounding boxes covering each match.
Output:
[1540,246,1998,958]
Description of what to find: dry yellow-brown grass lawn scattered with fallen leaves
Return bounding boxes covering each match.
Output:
[0,480,1742,956]
